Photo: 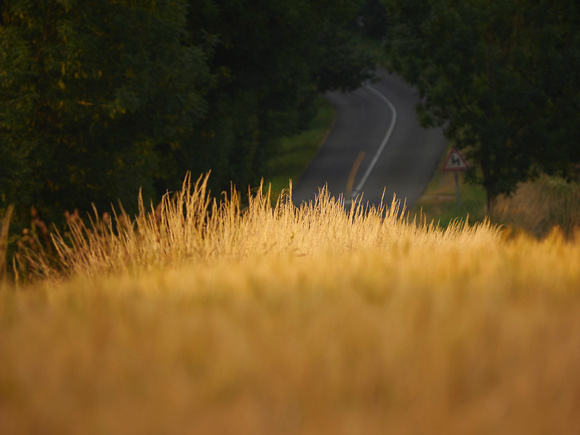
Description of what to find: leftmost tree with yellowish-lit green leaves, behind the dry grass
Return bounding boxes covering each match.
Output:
[0,0,211,221]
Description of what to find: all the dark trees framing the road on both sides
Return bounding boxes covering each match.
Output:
[0,0,580,225]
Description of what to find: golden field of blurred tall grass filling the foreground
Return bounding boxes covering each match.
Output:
[0,175,580,435]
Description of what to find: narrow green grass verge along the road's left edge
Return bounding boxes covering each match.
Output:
[264,95,335,199]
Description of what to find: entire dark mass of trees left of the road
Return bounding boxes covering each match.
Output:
[0,0,374,228]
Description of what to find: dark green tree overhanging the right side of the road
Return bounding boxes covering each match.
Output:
[385,0,580,209]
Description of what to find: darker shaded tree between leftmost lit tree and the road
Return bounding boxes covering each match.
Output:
[188,0,374,192]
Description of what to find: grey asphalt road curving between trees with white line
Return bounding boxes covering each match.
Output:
[292,71,447,208]
